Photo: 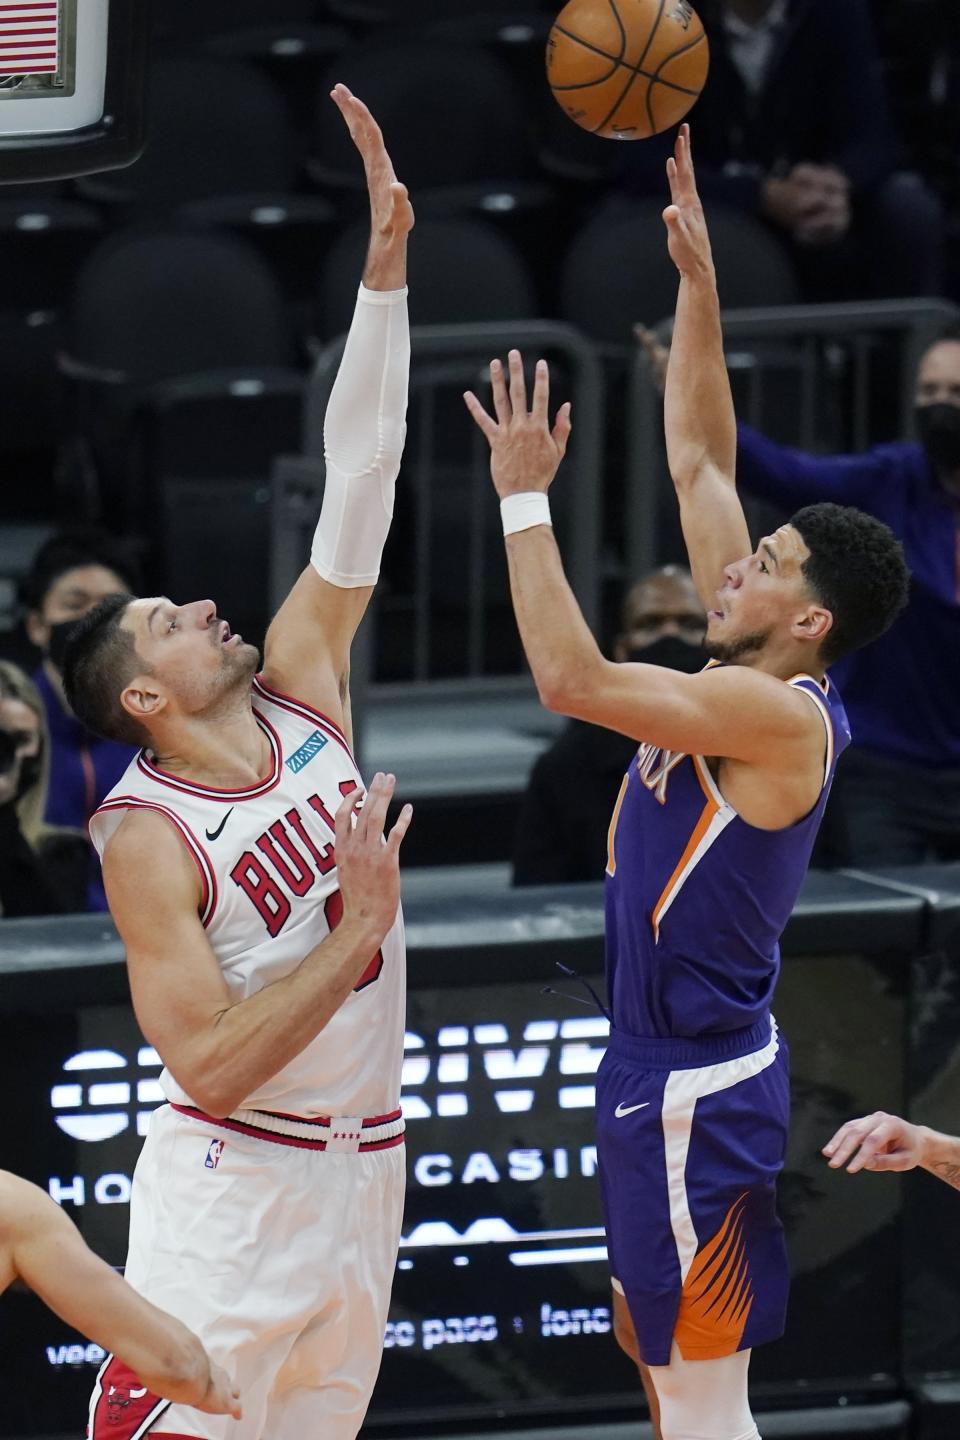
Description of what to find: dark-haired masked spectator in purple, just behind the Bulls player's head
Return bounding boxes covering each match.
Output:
[23,530,138,910]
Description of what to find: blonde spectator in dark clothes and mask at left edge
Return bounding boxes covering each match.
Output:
[0,661,89,917]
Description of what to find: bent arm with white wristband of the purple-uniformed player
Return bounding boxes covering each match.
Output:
[465,350,819,765]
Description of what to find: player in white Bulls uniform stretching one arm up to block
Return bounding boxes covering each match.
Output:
[65,85,413,1440]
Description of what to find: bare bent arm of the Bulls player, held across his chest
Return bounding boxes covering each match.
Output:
[104,775,412,1116]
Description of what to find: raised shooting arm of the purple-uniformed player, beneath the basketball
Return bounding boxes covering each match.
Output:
[664,125,753,609]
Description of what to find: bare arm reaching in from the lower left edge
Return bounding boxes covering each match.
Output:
[0,1172,242,1420]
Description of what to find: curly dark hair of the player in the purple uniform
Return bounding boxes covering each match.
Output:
[790,501,910,665]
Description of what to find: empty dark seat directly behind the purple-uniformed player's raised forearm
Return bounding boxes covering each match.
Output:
[560,200,797,344]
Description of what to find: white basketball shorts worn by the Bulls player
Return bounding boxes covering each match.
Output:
[88,1106,404,1440]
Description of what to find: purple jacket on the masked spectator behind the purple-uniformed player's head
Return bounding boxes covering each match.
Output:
[737,425,960,768]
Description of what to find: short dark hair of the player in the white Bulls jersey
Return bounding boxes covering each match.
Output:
[63,595,150,744]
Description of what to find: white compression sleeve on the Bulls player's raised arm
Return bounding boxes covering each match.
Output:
[311,285,410,589]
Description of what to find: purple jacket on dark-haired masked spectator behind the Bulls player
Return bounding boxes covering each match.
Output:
[33,665,137,910]
